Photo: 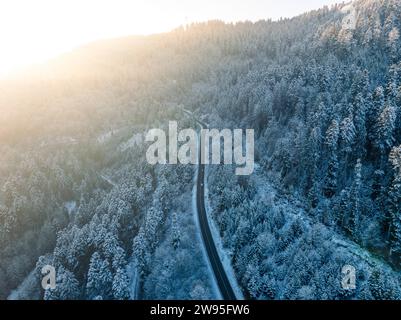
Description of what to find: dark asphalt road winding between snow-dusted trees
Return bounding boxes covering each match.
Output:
[196,127,237,300]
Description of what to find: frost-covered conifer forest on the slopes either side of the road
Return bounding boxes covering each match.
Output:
[0,0,401,299]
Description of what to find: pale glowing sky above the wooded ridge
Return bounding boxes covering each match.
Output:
[0,0,342,75]
